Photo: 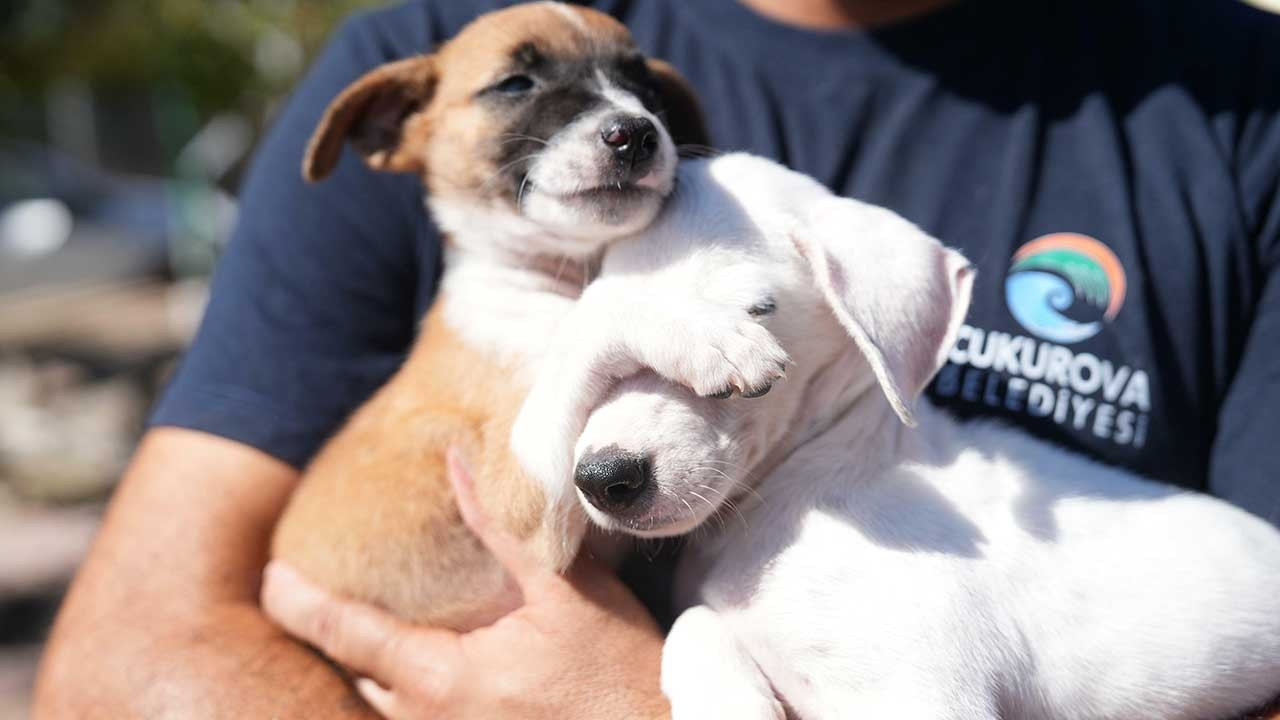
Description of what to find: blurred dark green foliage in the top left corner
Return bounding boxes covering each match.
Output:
[0,0,385,169]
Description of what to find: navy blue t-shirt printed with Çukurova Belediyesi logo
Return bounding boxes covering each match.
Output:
[154,0,1280,523]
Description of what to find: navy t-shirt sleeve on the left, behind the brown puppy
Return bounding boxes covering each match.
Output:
[151,6,440,466]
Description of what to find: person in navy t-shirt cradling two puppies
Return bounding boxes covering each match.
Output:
[36,0,1280,717]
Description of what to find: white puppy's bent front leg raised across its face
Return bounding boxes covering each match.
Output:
[511,277,790,511]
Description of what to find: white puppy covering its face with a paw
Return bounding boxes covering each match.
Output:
[512,155,1280,720]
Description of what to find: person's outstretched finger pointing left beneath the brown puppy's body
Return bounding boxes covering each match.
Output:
[262,561,457,687]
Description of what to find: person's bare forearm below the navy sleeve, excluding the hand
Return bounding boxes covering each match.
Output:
[35,428,376,719]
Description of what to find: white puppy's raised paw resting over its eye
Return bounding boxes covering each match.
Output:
[640,302,791,398]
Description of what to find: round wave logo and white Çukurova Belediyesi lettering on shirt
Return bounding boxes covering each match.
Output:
[934,233,1151,447]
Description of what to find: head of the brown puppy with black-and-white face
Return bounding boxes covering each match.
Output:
[314,3,701,255]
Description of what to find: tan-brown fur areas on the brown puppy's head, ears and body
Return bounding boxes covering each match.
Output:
[273,4,705,629]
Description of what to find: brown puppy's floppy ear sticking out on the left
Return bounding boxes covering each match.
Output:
[302,55,436,182]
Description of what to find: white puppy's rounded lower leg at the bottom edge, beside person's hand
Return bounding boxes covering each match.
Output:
[662,605,786,720]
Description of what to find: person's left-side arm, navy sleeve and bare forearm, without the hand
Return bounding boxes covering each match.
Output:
[36,3,440,717]
